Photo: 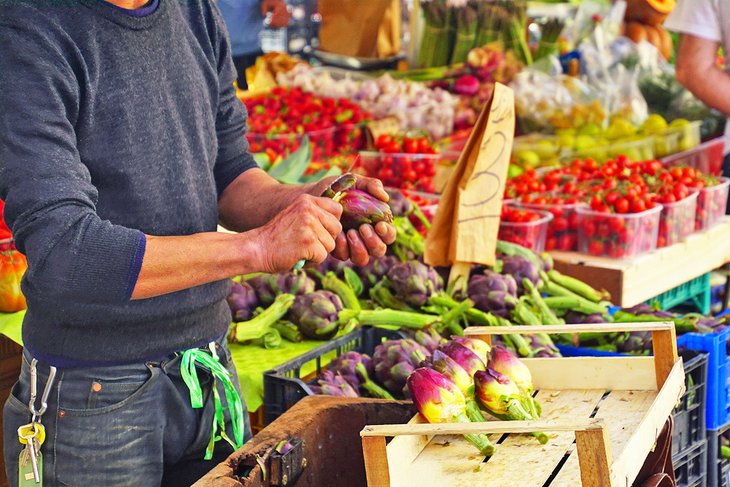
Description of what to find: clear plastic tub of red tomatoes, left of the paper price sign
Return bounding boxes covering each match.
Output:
[352,152,441,193]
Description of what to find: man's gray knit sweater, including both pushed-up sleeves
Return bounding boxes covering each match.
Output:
[0,0,255,366]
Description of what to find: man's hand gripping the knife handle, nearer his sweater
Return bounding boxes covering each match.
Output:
[253,194,342,273]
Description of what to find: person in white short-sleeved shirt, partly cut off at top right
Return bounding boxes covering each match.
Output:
[664,0,730,185]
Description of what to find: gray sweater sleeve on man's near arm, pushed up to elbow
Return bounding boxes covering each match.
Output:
[0,23,145,304]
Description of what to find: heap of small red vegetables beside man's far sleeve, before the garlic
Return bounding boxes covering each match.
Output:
[243,87,370,160]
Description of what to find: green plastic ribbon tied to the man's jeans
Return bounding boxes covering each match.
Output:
[180,343,244,460]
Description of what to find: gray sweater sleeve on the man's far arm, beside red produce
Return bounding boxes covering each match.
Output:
[213,5,258,196]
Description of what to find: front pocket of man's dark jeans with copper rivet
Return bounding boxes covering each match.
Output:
[59,366,161,416]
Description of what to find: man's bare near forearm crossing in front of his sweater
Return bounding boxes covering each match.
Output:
[132,232,262,300]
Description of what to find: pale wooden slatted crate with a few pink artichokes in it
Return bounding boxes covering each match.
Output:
[361,323,684,487]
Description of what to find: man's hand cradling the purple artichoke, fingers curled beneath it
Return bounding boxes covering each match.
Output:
[332,176,396,267]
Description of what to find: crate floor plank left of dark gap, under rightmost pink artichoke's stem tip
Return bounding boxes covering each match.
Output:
[473,390,603,487]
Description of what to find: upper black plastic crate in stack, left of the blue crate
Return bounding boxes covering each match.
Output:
[672,350,707,458]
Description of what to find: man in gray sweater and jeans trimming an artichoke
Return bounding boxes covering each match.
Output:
[0,0,395,486]
